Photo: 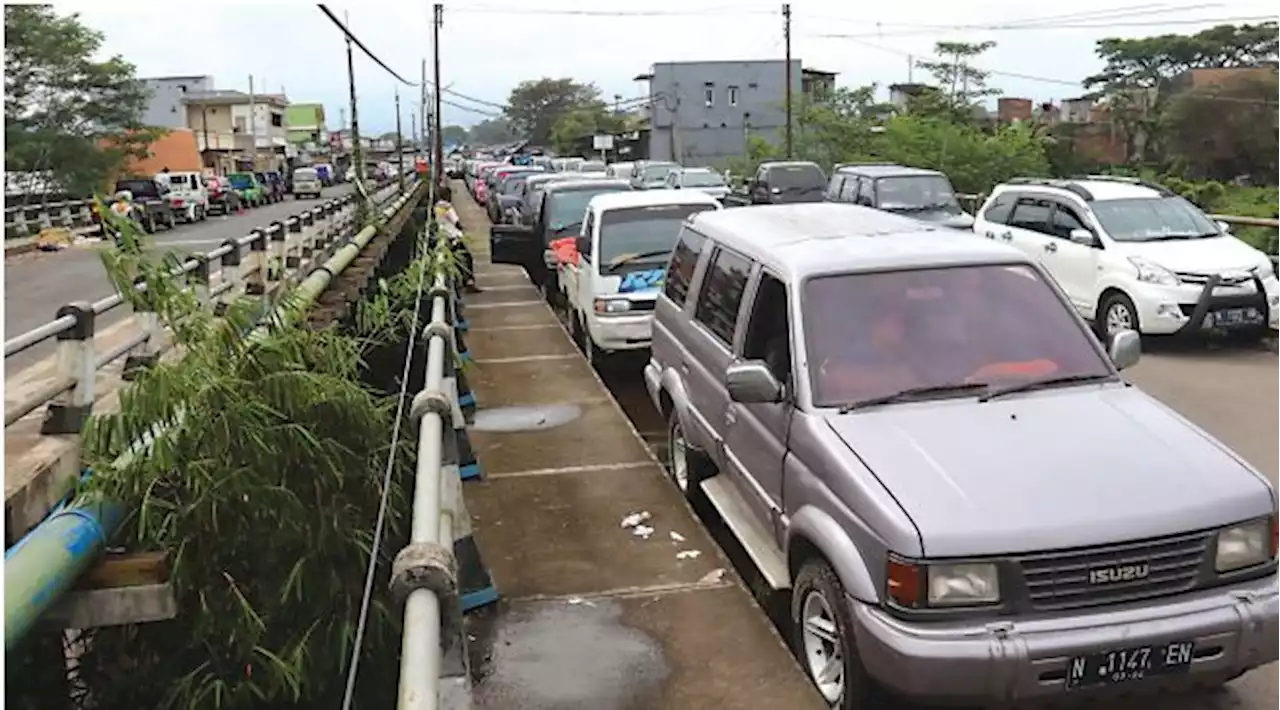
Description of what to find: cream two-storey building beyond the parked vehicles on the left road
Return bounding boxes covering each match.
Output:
[183,91,296,173]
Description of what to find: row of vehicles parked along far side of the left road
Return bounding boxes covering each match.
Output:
[93,168,335,233]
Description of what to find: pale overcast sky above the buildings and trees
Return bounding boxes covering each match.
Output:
[64,0,1280,133]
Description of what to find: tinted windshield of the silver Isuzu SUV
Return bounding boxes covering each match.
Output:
[800,265,1112,407]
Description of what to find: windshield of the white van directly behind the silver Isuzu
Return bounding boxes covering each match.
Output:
[599,205,716,272]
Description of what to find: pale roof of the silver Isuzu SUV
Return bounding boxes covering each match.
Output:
[692,202,1030,278]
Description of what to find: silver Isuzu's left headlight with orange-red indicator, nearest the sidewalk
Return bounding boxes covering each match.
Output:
[887,556,1001,609]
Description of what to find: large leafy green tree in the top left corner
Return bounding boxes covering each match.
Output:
[4,5,159,194]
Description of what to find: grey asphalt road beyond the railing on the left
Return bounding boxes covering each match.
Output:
[4,184,351,375]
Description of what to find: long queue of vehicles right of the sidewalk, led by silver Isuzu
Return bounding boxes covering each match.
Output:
[466,151,1280,710]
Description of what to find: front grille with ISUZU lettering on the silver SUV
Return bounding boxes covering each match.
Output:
[1016,532,1213,610]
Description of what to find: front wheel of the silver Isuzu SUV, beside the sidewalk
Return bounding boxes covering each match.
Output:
[791,556,874,710]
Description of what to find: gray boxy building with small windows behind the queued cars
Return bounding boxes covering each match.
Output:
[636,59,836,166]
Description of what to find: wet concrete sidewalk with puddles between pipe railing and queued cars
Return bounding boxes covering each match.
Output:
[456,189,826,710]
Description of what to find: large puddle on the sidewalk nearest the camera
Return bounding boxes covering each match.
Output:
[472,600,671,710]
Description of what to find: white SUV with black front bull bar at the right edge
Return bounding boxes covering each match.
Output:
[973,175,1280,335]
